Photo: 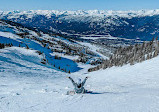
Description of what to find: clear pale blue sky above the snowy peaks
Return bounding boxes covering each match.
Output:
[0,0,159,10]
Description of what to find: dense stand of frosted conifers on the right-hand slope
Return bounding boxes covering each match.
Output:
[88,37,159,72]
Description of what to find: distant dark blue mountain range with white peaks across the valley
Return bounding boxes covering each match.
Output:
[0,9,159,40]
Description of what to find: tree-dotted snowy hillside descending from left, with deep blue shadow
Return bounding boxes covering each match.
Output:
[0,20,111,72]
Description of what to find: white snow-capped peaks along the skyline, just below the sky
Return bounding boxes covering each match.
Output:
[0,9,159,18]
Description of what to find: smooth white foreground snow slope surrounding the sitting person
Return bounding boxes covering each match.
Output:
[0,47,159,112]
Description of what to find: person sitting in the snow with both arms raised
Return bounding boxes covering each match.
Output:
[67,77,88,93]
